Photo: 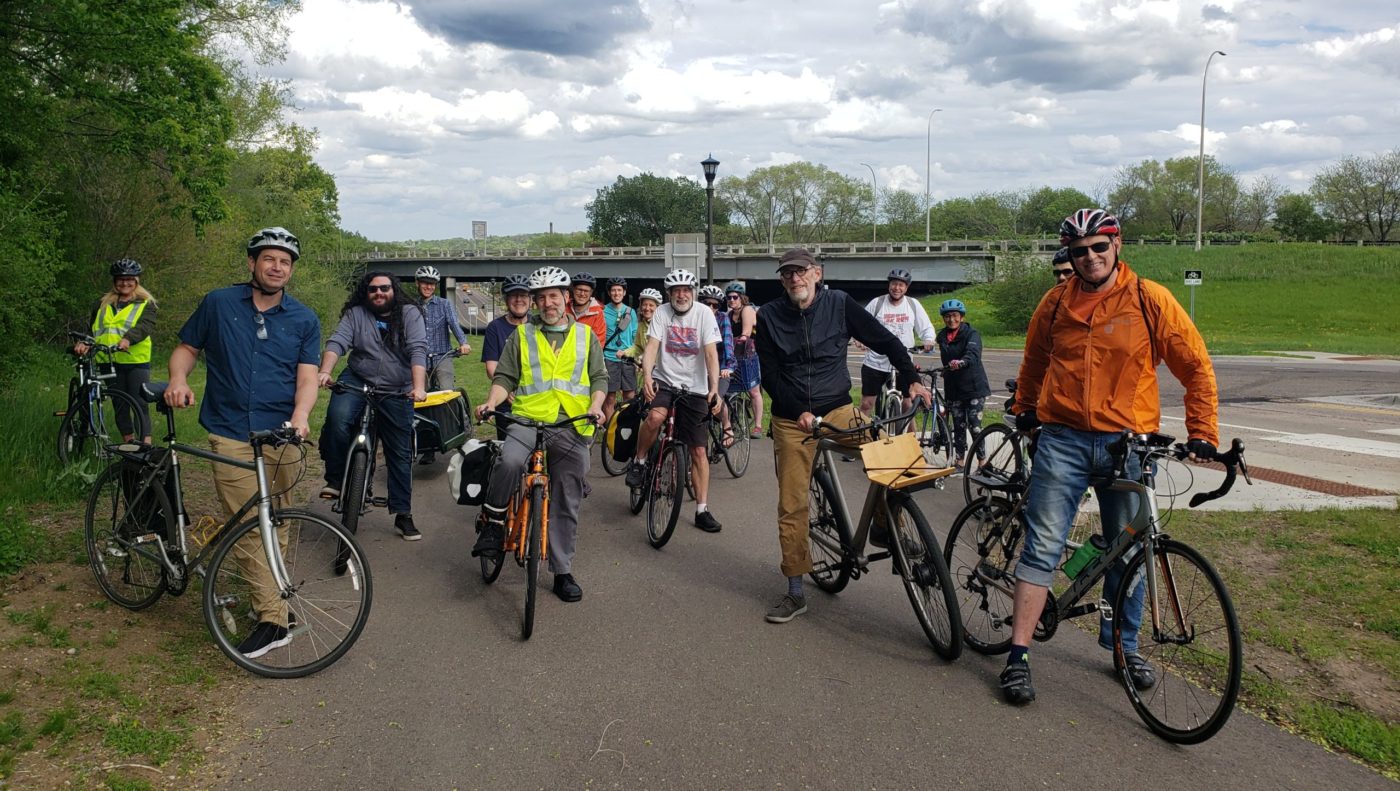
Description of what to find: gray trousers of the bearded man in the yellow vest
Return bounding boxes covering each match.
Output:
[486,426,592,574]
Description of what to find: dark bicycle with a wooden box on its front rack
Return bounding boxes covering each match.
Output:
[808,412,963,661]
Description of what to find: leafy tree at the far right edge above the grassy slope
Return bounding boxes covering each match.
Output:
[1312,148,1400,242]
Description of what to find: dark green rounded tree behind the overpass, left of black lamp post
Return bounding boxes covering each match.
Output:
[587,174,729,246]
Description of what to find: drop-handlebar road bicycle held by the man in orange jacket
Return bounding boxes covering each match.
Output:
[944,431,1252,745]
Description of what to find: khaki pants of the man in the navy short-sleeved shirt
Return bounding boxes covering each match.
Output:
[209,434,301,627]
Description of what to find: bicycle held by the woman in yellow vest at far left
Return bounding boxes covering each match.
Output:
[53,332,146,463]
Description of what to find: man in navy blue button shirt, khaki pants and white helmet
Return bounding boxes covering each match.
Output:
[165,228,321,658]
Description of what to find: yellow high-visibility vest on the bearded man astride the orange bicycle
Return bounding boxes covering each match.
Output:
[511,322,594,437]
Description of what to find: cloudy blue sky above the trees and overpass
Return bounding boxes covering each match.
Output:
[263,0,1400,241]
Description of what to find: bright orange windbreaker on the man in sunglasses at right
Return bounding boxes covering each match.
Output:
[1016,259,1219,445]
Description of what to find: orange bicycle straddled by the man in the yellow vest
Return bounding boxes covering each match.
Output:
[476,412,592,640]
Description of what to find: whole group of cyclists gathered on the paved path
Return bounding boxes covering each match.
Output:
[73,209,1219,704]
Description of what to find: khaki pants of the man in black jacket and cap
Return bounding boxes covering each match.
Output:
[769,405,869,577]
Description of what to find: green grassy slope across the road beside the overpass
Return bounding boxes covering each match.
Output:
[923,244,1400,356]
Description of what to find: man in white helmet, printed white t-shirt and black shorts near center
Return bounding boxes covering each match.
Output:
[627,269,721,533]
